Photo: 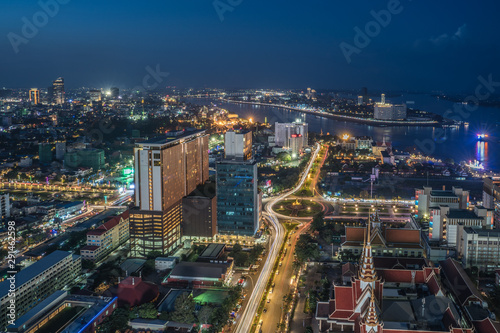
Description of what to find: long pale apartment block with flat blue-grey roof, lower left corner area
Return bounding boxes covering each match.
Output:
[0,250,82,331]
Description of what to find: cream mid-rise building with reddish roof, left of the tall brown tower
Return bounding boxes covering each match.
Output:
[80,210,130,261]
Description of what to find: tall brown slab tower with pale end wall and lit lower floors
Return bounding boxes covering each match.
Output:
[130,130,208,258]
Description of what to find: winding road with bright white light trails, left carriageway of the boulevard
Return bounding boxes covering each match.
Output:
[235,145,321,333]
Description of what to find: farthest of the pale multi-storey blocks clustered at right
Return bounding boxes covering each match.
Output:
[415,186,469,217]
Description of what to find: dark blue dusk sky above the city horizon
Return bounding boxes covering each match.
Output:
[0,0,500,91]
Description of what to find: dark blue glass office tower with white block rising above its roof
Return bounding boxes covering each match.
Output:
[216,133,261,236]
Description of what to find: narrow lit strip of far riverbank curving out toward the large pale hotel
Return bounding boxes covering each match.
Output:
[222,99,441,127]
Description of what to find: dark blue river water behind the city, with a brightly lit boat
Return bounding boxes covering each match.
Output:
[186,94,500,171]
